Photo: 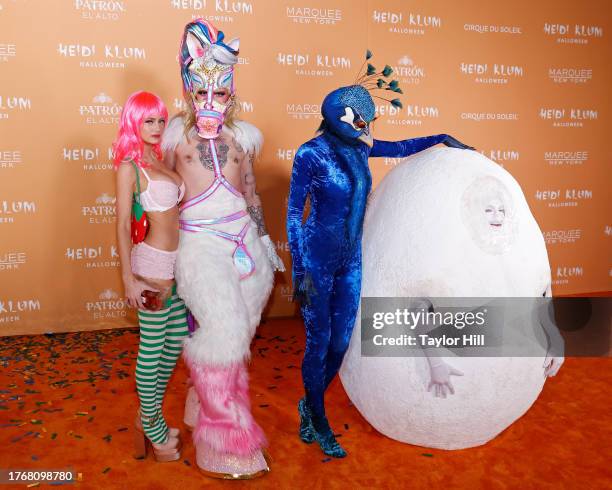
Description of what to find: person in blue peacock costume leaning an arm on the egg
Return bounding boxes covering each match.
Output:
[287,61,472,458]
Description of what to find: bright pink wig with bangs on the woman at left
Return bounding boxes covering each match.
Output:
[113,91,168,169]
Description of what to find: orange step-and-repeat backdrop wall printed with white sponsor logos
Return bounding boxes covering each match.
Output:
[0,0,612,335]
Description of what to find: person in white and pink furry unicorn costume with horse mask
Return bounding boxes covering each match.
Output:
[162,19,284,478]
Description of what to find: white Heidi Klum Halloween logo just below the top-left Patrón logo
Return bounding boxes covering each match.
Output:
[57,43,147,69]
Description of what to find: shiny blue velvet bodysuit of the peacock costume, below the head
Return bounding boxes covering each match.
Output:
[287,130,446,424]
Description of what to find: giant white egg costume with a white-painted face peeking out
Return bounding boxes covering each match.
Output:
[340,147,550,449]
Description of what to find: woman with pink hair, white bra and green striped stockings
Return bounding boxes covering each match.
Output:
[113,92,188,461]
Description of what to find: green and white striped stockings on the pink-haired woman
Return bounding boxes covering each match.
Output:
[136,288,189,444]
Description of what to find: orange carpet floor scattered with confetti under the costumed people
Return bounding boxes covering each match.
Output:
[0,319,612,490]
